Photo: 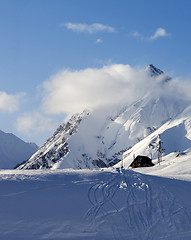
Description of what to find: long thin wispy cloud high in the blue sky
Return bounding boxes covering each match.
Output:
[61,22,115,34]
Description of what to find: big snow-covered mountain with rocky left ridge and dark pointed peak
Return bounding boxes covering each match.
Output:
[19,65,190,169]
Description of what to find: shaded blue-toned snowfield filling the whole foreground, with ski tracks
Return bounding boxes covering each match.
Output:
[0,169,191,240]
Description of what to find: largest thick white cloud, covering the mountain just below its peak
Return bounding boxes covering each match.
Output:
[42,64,185,115]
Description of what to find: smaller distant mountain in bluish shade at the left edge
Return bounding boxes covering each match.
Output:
[0,130,38,169]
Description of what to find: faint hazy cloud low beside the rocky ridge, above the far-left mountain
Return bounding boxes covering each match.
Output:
[16,112,55,136]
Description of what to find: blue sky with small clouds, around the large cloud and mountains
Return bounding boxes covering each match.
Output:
[0,0,191,144]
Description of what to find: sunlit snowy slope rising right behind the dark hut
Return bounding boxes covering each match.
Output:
[116,107,191,171]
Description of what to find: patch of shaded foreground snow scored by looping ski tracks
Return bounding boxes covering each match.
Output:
[86,170,191,240]
